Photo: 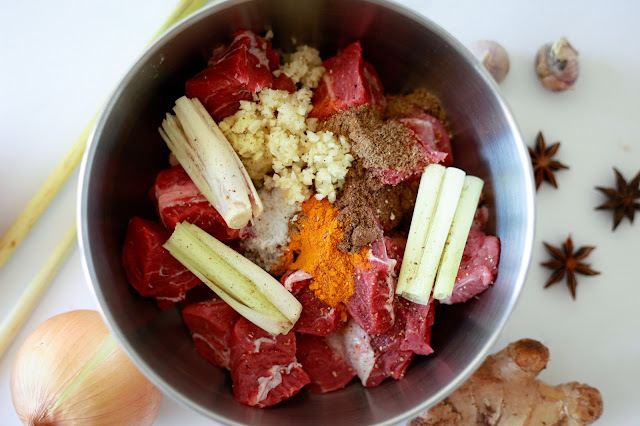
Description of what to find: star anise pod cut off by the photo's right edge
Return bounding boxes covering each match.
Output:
[596,167,640,230]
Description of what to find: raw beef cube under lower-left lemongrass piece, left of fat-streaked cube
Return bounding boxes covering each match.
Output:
[182,299,240,368]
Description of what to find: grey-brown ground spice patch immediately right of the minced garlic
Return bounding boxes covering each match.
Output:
[319,105,424,176]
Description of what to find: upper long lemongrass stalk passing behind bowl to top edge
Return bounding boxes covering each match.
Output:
[0,0,214,269]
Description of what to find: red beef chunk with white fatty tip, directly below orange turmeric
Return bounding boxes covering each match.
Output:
[280,271,346,336]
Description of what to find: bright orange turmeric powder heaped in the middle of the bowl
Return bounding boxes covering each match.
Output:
[284,197,368,307]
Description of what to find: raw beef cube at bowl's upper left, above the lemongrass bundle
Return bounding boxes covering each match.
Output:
[185,30,280,121]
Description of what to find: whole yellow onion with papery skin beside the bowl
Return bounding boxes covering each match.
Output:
[11,310,162,426]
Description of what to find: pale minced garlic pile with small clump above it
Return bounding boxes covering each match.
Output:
[218,46,353,204]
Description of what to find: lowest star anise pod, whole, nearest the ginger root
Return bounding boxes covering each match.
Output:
[541,235,600,300]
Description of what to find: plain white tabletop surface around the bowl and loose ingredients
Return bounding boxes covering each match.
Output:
[0,0,640,425]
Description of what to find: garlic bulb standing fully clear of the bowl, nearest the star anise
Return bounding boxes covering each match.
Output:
[536,37,578,92]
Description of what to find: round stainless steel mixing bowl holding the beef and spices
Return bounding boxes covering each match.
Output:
[78,0,534,426]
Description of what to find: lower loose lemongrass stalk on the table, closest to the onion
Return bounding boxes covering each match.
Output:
[0,223,77,357]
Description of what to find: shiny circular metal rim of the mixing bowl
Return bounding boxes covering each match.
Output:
[76,0,535,425]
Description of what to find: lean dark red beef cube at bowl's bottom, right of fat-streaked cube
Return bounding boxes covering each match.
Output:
[296,334,356,393]
